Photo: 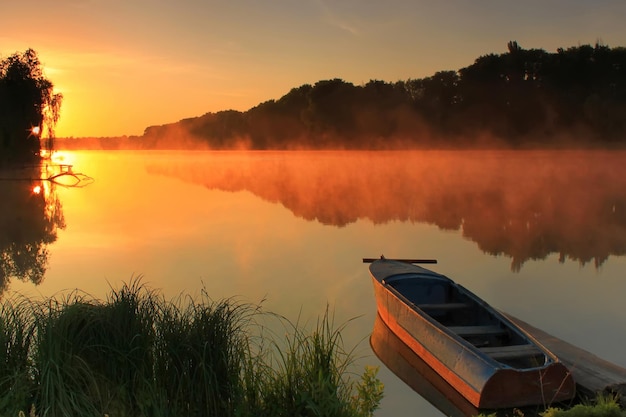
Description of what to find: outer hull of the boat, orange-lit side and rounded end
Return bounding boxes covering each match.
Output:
[370,261,575,409]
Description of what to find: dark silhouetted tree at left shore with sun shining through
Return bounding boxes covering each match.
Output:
[0,49,62,164]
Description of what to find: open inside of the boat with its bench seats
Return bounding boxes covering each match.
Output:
[385,275,550,369]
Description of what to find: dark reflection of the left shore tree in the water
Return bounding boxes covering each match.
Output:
[0,166,65,294]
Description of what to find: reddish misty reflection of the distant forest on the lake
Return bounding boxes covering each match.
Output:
[148,151,626,271]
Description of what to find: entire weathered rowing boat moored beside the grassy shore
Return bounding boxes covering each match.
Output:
[363,257,576,409]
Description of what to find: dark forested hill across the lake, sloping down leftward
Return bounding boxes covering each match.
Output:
[58,41,626,149]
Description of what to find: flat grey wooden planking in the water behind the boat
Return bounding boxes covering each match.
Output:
[507,314,626,406]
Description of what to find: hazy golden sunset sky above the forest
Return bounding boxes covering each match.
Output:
[0,0,626,137]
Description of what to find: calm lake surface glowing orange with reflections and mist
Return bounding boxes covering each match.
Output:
[0,152,626,416]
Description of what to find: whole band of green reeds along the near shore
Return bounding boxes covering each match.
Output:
[0,279,383,417]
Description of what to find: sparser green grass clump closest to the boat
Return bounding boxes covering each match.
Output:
[246,309,382,417]
